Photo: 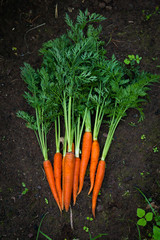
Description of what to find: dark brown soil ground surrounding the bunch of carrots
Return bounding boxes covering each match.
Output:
[0,0,160,240]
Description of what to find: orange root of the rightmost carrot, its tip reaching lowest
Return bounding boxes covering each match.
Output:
[92,160,105,218]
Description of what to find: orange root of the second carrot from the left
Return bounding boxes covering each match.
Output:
[53,152,62,210]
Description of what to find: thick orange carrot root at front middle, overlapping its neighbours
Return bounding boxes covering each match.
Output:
[64,152,75,212]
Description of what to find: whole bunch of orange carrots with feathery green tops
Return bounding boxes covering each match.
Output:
[17,10,159,217]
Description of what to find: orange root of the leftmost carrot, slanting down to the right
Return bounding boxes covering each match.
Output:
[43,160,62,211]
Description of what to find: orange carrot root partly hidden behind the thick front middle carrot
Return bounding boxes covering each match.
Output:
[73,157,80,205]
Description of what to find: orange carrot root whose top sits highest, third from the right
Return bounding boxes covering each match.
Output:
[78,132,92,194]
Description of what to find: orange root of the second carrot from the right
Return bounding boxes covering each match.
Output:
[88,140,100,195]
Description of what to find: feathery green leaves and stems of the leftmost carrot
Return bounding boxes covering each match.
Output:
[17,63,58,160]
